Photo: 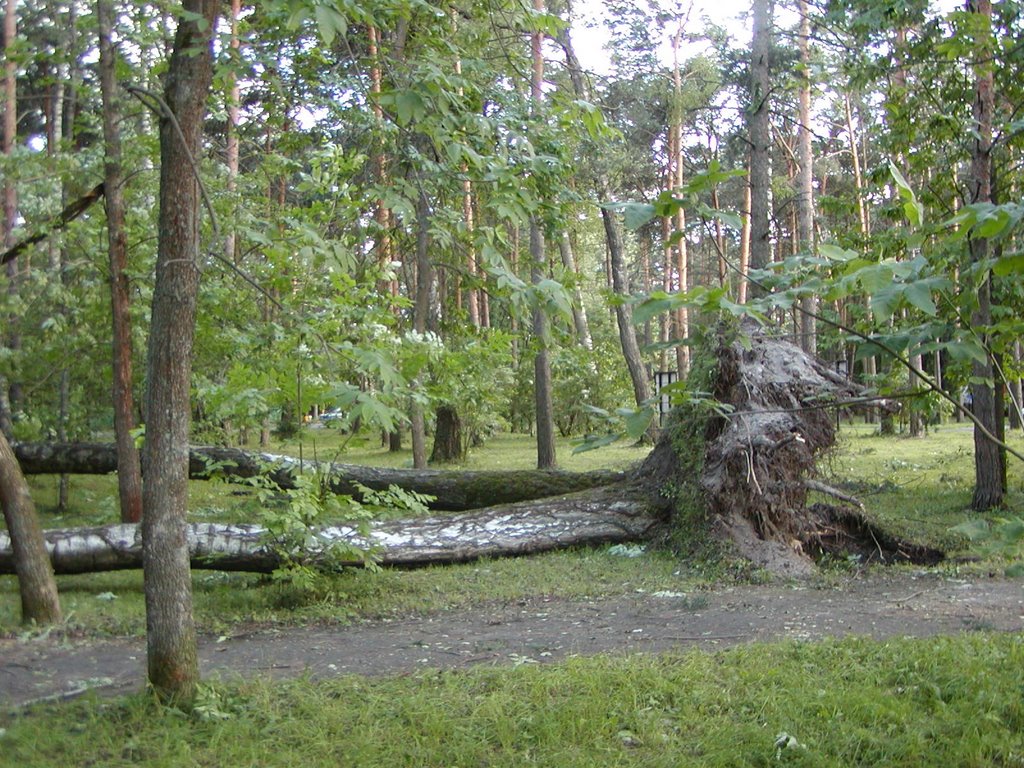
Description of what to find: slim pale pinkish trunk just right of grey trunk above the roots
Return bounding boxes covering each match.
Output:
[797,0,817,354]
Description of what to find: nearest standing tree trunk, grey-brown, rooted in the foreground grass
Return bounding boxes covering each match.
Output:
[142,0,220,705]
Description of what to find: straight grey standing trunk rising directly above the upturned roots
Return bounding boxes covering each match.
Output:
[748,0,774,284]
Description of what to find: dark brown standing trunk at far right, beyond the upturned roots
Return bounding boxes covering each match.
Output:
[967,0,1006,511]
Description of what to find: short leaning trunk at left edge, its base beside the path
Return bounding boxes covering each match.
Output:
[0,434,60,625]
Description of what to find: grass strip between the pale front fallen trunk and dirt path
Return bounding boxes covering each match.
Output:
[0,548,704,636]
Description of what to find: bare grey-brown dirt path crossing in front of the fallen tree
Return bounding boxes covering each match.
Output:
[0,572,1024,710]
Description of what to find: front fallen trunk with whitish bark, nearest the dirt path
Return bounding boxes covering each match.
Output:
[0,486,664,573]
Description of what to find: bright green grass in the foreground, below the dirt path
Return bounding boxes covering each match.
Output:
[0,634,1024,768]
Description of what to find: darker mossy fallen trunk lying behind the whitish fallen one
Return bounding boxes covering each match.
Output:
[14,442,627,512]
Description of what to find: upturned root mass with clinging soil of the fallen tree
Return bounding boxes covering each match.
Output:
[638,321,943,577]
